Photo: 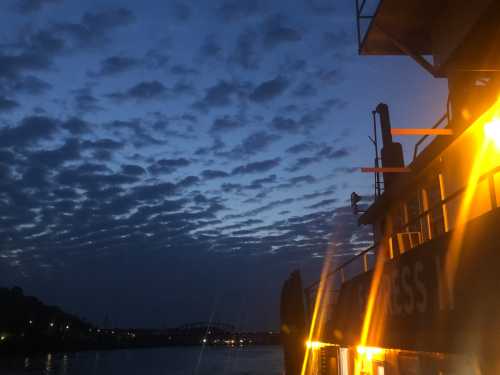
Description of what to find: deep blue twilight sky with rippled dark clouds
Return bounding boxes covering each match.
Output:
[0,0,446,329]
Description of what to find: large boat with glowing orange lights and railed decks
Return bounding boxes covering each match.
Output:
[286,0,500,375]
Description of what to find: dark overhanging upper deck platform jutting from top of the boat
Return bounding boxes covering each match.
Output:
[360,0,500,72]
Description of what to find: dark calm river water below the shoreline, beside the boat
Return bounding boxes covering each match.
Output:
[0,346,283,375]
